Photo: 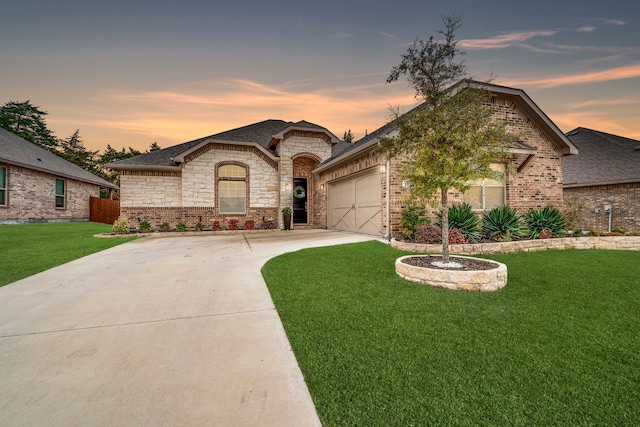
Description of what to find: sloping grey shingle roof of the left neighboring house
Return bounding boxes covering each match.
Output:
[0,128,118,188]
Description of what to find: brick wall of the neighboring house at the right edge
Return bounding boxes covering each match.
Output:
[563,182,640,233]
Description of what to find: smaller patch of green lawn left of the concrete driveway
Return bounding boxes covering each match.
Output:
[0,222,134,286]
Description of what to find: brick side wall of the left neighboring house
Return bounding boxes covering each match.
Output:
[0,165,100,223]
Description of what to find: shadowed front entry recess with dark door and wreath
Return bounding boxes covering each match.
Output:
[293,153,320,225]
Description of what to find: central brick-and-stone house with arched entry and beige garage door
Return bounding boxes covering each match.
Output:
[108,80,577,236]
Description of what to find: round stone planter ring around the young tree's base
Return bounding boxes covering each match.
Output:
[396,255,507,292]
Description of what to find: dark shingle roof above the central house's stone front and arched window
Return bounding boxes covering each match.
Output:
[107,119,338,169]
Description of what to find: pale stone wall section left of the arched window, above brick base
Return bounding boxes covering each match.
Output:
[120,171,182,209]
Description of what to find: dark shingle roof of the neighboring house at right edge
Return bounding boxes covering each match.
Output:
[562,127,640,185]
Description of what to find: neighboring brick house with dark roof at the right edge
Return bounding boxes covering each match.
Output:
[563,127,640,232]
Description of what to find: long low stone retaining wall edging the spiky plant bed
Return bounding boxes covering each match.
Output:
[391,236,640,255]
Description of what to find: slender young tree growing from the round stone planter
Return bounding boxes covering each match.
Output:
[381,15,515,263]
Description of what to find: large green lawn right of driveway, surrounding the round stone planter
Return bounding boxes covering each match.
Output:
[263,242,640,426]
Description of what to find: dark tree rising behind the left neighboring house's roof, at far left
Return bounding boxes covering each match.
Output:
[0,101,58,152]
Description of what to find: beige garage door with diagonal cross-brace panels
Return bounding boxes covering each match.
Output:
[329,168,382,235]
